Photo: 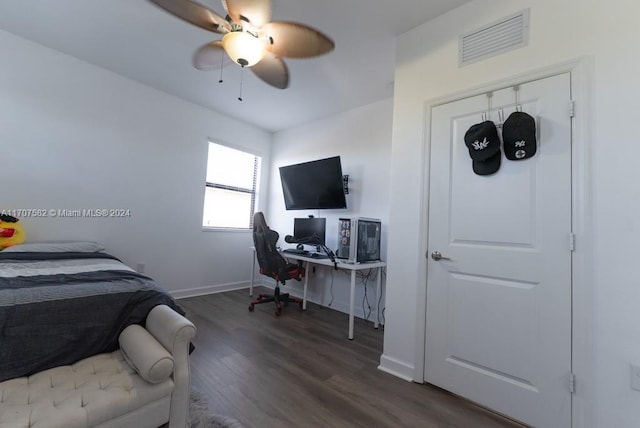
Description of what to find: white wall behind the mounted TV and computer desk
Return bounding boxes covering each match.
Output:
[267,99,393,320]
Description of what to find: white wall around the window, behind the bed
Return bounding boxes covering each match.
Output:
[0,31,271,294]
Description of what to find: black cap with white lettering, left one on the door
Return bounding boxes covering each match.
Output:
[464,120,502,175]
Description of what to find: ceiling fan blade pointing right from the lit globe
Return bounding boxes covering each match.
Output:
[260,22,335,58]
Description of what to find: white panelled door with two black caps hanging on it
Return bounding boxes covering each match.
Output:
[425,73,571,428]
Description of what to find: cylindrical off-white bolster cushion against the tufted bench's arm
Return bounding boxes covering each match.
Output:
[118,324,174,383]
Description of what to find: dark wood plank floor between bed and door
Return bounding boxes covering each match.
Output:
[180,288,519,428]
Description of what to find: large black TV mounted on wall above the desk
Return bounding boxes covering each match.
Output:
[280,156,347,210]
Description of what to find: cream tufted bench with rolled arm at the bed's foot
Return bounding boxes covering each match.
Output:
[0,305,195,428]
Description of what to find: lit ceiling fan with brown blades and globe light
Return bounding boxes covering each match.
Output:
[151,0,335,89]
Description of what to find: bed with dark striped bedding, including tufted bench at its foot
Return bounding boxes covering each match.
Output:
[0,242,196,428]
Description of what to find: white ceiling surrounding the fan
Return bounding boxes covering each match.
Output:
[0,0,469,131]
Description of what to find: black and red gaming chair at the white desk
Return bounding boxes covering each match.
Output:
[249,212,305,316]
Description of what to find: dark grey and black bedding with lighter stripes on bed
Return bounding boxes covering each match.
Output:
[0,252,184,381]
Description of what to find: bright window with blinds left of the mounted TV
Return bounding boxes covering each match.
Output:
[202,142,262,229]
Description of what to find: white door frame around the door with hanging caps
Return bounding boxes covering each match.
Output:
[413,57,596,428]
